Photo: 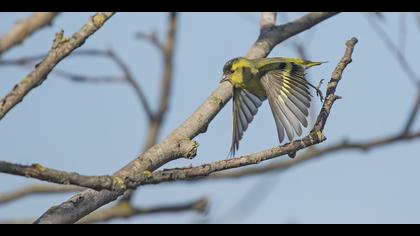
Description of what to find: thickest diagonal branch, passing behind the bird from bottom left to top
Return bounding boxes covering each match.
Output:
[35,13,335,223]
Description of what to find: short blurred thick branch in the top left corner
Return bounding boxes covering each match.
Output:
[0,12,58,56]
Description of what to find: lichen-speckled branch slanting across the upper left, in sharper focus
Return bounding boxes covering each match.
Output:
[0,12,114,120]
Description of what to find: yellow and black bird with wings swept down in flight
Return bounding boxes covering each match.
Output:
[220,57,325,158]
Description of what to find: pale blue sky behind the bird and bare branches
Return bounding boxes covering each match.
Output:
[0,13,420,223]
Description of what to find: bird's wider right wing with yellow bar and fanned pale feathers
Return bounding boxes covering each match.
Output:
[261,63,311,142]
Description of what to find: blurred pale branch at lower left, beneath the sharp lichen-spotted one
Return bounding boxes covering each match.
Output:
[0,184,85,204]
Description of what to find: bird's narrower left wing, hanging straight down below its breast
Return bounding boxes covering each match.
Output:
[229,88,265,157]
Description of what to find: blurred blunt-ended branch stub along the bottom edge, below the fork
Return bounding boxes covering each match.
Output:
[77,198,208,224]
